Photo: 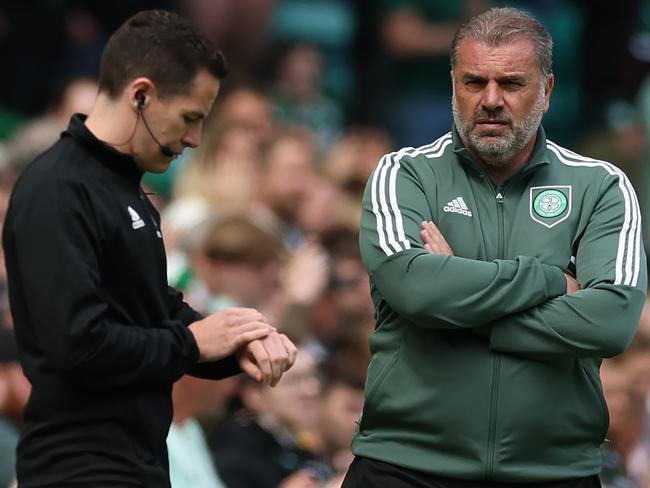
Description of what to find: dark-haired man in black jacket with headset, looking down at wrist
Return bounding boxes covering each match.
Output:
[3,10,296,488]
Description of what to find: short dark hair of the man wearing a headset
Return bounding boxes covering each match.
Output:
[99,10,228,98]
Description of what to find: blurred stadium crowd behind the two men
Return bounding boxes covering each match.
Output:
[0,0,650,488]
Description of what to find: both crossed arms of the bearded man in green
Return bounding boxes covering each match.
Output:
[360,158,646,359]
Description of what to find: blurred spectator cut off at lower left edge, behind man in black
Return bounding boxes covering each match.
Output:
[0,327,31,488]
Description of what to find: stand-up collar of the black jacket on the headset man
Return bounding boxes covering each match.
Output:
[61,114,143,184]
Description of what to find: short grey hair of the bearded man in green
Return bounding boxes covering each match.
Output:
[449,7,553,81]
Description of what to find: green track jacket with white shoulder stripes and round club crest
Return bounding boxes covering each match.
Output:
[353,128,647,482]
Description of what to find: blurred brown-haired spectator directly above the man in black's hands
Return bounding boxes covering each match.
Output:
[186,215,328,338]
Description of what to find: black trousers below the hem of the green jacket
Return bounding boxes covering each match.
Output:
[341,456,601,488]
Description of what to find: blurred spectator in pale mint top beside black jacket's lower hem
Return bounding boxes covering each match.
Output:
[167,376,236,488]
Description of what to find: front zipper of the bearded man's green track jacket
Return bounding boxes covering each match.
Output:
[485,184,506,479]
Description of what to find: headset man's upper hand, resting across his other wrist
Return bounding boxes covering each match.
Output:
[189,308,276,362]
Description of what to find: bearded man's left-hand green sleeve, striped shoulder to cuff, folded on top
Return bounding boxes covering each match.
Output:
[360,152,566,328]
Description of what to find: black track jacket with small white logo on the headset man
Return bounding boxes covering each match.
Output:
[3,115,239,488]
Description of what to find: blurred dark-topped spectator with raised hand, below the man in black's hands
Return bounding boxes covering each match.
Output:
[210,349,331,488]
